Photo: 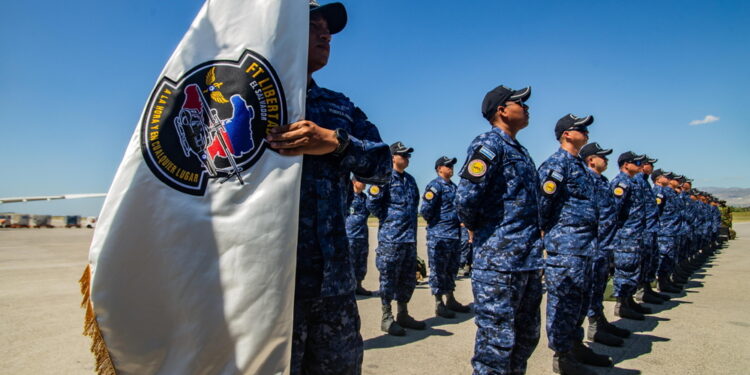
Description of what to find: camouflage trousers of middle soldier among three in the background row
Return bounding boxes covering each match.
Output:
[375,242,417,304]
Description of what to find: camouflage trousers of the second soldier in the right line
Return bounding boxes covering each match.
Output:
[544,253,592,353]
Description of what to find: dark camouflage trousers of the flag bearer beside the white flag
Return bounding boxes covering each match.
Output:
[291,293,363,375]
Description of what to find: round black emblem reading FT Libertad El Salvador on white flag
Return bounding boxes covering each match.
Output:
[140,50,287,195]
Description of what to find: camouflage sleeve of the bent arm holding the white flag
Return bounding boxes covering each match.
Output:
[341,107,391,185]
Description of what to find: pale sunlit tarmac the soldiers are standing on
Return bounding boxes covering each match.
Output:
[0,223,750,374]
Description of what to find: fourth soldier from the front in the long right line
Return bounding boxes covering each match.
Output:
[610,151,646,320]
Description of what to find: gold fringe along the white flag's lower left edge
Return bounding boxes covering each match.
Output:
[78,265,117,375]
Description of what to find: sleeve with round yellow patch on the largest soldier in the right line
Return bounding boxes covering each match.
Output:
[455,141,506,230]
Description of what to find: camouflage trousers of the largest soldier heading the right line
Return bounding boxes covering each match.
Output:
[471,270,542,375]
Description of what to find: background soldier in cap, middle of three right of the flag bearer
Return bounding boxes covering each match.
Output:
[367,142,426,336]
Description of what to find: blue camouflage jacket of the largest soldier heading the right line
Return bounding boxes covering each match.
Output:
[456,128,543,271]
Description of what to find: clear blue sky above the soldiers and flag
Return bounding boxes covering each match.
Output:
[0,0,750,215]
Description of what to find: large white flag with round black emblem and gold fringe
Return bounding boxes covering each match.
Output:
[81,0,309,374]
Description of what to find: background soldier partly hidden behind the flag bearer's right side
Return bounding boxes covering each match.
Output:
[346,176,372,296]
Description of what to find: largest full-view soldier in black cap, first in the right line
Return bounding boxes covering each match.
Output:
[456,86,542,374]
